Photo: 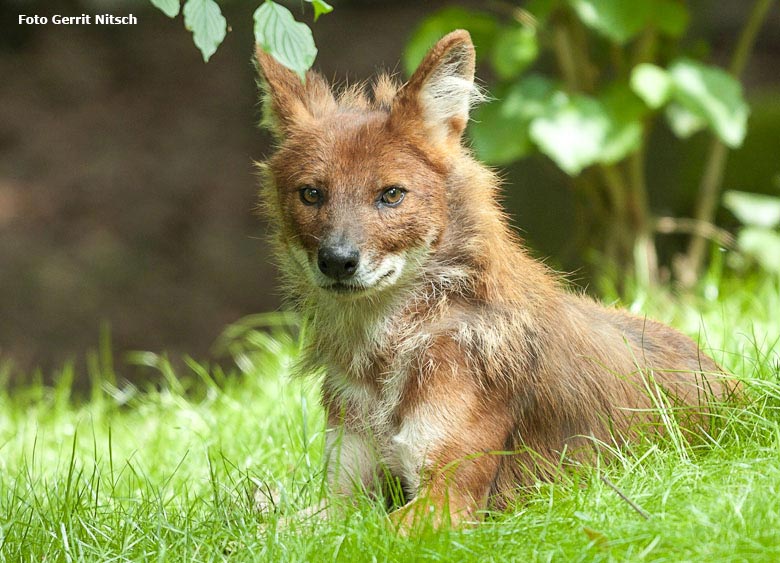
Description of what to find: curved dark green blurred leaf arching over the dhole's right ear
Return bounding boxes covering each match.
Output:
[403,7,499,75]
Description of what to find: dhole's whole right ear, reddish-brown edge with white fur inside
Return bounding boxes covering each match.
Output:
[392,29,481,142]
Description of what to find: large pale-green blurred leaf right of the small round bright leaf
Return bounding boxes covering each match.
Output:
[669,59,749,148]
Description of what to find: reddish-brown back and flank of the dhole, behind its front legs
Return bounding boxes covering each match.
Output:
[492,291,736,507]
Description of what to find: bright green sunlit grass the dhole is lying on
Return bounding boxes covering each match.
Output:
[0,279,780,562]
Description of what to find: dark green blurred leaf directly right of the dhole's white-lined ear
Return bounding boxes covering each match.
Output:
[469,75,555,165]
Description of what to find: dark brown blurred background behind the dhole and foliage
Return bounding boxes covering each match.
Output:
[0,0,780,382]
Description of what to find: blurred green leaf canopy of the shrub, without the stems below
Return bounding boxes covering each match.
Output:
[405,0,748,172]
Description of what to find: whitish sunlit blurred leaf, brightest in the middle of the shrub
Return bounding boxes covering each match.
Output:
[531,94,611,176]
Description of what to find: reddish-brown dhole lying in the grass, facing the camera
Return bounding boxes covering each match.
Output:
[257,31,728,529]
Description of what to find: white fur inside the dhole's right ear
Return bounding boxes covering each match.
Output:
[420,48,484,141]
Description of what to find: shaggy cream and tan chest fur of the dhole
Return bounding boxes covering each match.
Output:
[319,304,432,490]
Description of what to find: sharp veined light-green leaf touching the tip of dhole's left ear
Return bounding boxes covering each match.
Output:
[254,0,317,80]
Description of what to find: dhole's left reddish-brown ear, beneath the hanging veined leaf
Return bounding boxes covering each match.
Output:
[255,45,336,139]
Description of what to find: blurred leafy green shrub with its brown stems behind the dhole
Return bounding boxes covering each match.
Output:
[404,0,772,290]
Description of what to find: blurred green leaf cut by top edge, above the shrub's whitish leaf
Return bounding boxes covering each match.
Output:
[569,0,653,44]
